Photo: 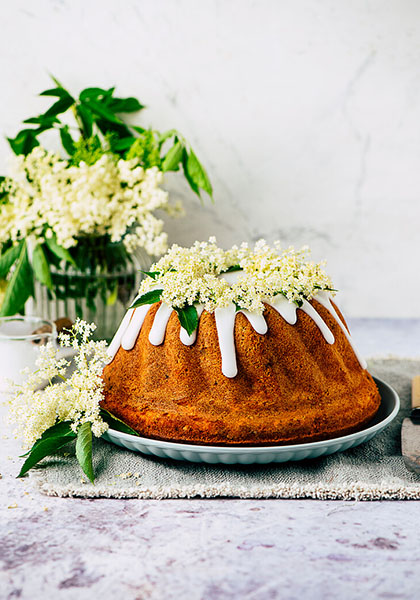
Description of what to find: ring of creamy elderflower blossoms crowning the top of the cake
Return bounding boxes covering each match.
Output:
[140,238,333,314]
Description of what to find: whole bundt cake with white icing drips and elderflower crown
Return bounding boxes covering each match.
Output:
[102,238,380,445]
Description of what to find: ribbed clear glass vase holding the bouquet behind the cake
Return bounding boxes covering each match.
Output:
[33,236,151,341]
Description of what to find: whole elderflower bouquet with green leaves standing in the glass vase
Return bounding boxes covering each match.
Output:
[0,79,212,337]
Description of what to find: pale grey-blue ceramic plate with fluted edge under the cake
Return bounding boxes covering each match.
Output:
[102,378,400,465]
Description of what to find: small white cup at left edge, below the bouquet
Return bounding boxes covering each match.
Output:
[0,316,57,392]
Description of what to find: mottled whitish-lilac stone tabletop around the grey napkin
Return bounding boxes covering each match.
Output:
[0,321,420,600]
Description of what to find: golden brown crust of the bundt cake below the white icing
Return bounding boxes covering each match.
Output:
[102,300,380,446]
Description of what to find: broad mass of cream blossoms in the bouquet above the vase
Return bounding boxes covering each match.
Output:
[0,146,181,256]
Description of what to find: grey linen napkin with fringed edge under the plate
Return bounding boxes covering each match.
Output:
[32,358,420,500]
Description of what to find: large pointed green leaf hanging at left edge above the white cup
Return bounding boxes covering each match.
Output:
[0,243,34,317]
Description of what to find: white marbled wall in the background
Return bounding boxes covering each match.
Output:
[0,0,420,317]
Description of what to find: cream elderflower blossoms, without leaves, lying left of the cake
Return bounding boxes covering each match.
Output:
[9,320,109,448]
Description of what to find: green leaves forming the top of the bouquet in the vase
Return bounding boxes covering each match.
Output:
[4,77,213,200]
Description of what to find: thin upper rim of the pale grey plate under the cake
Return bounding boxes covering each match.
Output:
[102,375,401,454]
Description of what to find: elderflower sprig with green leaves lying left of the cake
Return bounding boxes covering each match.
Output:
[9,320,137,482]
